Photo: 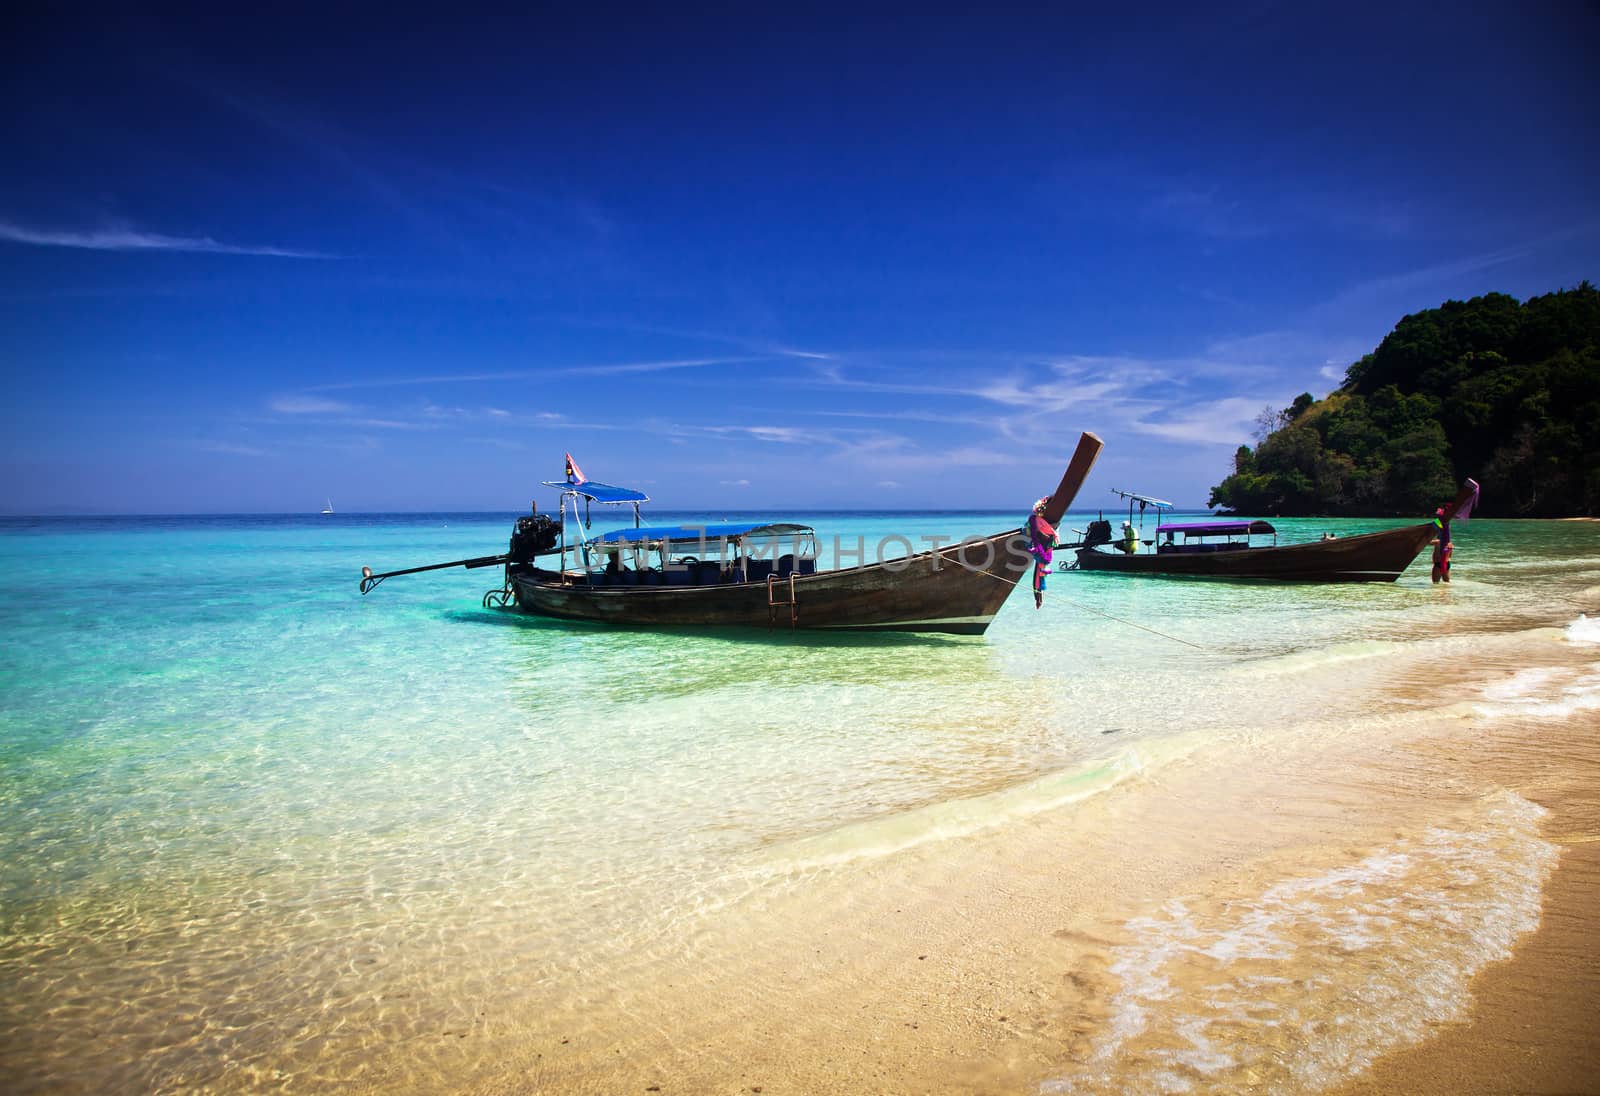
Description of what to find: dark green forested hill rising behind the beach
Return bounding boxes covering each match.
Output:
[1210,282,1600,517]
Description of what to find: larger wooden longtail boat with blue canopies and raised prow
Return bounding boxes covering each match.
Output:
[362,434,1101,635]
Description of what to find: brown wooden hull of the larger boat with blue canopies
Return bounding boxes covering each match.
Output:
[510,530,1032,635]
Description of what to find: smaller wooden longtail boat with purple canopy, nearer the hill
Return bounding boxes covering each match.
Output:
[1075,480,1478,582]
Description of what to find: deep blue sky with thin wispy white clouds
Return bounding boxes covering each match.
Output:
[0,3,1600,514]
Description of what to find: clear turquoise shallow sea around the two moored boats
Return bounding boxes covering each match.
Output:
[0,512,1600,1091]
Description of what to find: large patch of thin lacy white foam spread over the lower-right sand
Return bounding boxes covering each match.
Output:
[1042,792,1557,1093]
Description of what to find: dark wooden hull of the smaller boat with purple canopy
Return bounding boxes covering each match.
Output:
[1077,523,1438,582]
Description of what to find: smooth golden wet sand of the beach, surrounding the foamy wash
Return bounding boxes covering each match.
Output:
[396,680,1600,1093]
